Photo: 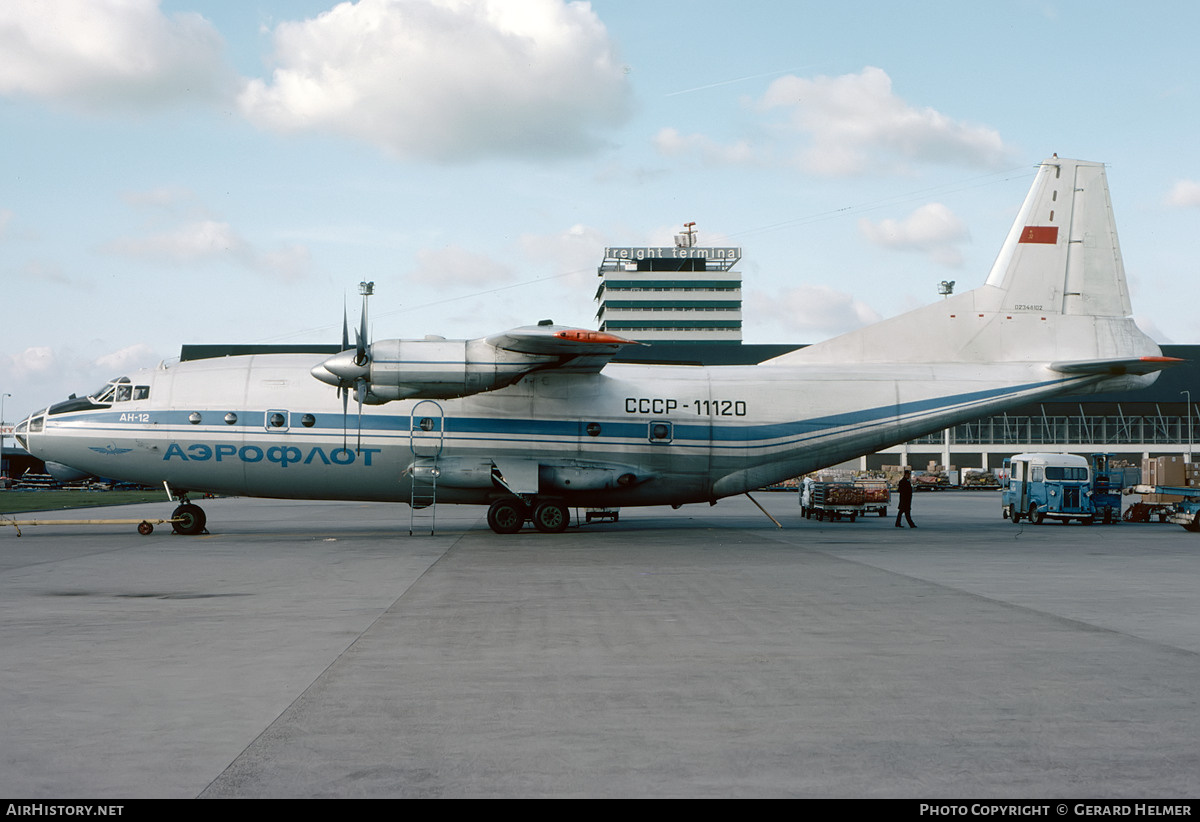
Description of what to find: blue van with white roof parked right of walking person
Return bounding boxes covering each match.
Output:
[1001,454,1096,526]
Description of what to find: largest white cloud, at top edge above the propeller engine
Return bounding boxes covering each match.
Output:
[239,0,629,162]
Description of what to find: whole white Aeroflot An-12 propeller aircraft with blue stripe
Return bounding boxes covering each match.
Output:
[17,156,1177,534]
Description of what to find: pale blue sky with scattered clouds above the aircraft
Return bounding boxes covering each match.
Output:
[0,0,1200,420]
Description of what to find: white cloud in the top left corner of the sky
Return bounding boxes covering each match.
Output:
[0,0,234,110]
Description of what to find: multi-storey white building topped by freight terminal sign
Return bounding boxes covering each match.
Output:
[595,223,742,344]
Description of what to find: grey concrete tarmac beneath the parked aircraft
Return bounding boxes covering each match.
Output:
[0,492,1200,799]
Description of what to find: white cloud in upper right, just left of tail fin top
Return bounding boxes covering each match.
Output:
[758,66,1009,176]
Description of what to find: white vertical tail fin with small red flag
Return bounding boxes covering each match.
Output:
[770,155,1162,365]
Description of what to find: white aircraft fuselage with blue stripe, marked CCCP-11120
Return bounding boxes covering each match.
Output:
[16,354,1132,506]
